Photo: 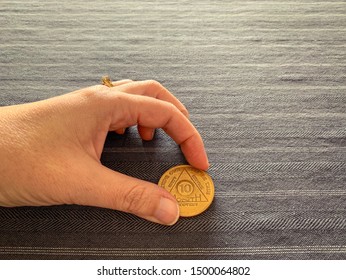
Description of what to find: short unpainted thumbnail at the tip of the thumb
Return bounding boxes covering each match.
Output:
[154,197,179,226]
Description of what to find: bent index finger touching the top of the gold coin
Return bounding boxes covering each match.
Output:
[111,93,209,170]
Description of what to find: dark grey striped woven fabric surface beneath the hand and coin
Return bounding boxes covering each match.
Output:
[0,0,346,259]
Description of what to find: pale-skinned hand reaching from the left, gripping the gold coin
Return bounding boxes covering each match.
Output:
[0,80,209,225]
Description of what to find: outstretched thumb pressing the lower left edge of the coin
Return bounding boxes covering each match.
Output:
[70,162,179,225]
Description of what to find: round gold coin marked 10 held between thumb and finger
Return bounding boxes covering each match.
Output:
[159,165,214,217]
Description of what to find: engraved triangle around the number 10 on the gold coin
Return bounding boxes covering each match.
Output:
[170,169,208,202]
